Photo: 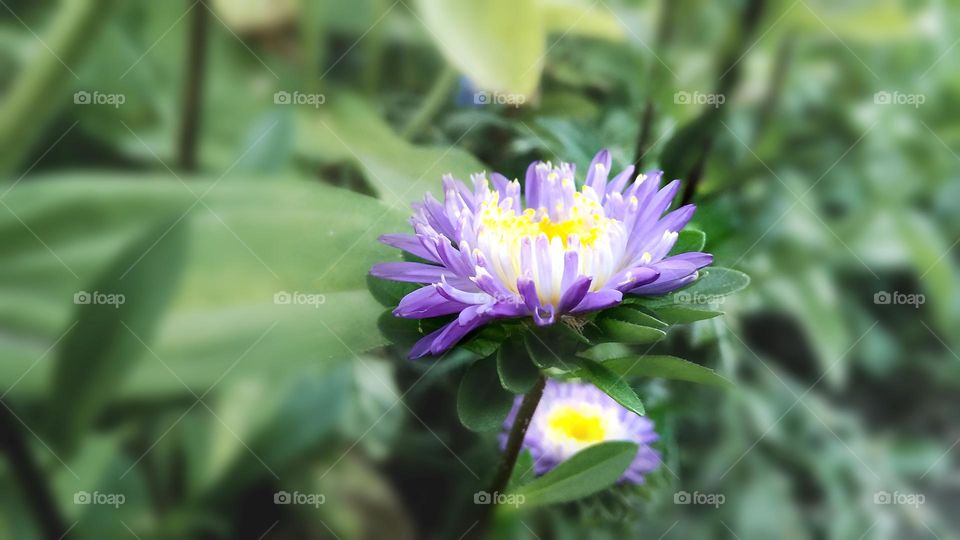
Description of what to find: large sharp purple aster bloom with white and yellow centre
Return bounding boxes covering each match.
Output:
[371,150,713,358]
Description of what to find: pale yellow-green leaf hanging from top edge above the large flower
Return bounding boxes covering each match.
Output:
[417,0,546,95]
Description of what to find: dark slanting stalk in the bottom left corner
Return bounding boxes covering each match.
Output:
[0,402,67,540]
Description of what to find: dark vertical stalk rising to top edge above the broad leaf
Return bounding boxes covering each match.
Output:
[177,2,210,172]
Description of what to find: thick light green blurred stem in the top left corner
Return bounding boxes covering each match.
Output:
[0,0,111,177]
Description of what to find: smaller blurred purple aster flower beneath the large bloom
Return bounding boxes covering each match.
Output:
[500,380,660,484]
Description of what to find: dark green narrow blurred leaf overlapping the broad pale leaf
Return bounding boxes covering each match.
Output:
[50,219,186,452]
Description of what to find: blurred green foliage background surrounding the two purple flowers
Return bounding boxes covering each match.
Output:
[0,0,960,539]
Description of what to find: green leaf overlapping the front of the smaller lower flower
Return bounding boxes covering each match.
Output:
[513,441,638,506]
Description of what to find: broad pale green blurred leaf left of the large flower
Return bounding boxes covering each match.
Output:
[0,173,404,401]
